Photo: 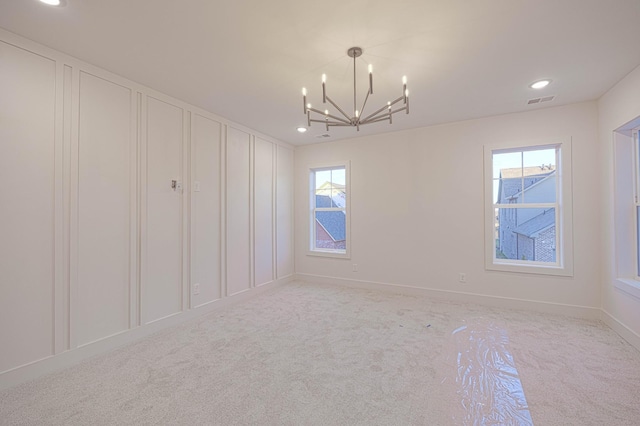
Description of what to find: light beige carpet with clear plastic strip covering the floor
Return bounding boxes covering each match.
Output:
[0,283,640,425]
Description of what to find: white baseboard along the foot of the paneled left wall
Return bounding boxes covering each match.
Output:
[0,275,294,390]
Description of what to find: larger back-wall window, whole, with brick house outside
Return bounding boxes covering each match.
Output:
[485,141,573,275]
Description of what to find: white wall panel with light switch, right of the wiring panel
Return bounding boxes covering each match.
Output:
[191,114,222,308]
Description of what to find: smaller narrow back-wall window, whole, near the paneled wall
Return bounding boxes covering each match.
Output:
[309,163,349,257]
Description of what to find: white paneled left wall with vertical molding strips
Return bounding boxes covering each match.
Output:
[0,30,293,388]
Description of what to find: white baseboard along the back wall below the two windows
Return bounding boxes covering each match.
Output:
[296,273,602,319]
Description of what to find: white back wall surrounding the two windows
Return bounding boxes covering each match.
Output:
[295,102,602,316]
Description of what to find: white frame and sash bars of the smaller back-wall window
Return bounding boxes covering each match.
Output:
[307,161,351,259]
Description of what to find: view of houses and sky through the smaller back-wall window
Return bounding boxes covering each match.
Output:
[315,182,347,250]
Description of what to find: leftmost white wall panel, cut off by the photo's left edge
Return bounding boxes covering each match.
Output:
[0,42,56,371]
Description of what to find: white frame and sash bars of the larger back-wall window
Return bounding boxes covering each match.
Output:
[484,137,573,276]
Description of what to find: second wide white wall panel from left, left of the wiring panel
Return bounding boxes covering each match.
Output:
[72,72,135,346]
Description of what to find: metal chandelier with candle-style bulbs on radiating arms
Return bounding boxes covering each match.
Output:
[302,47,409,131]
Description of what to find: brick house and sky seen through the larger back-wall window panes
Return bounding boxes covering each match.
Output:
[496,164,556,262]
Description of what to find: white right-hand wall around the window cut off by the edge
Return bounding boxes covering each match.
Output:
[598,63,640,348]
